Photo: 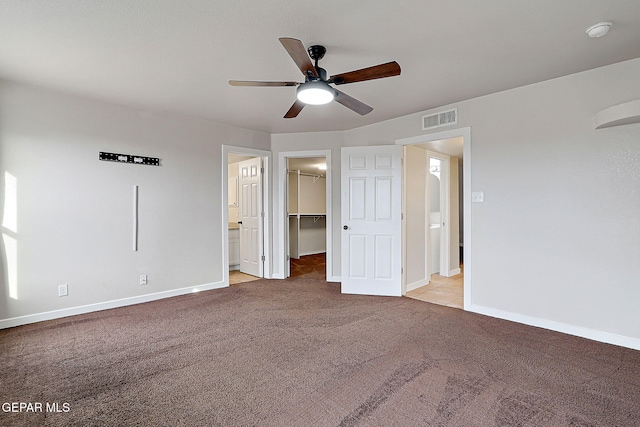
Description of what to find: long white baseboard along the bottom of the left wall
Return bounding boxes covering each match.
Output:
[0,281,229,329]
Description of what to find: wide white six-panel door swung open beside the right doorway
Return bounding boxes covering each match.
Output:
[341,145,402,296]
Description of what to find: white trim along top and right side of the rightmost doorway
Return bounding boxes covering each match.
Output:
[395,127,473,310]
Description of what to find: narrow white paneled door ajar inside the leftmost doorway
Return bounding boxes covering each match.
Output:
[239,157,263,277]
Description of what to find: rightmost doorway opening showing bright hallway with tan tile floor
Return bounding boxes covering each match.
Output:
[403,132,466,308]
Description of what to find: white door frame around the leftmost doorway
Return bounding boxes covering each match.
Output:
[220,144,273,286]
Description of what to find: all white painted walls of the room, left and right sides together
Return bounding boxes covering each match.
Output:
[0,59,640,348]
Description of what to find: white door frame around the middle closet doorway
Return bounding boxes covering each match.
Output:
[274,150,340,282]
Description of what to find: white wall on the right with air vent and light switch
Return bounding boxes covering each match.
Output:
[272,59,640,348]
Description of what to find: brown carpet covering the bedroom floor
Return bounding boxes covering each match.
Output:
[0,275,640,427]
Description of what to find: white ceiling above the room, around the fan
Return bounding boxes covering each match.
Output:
[0,0,640,133]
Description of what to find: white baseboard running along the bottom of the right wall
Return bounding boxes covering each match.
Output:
[464,304,640,350]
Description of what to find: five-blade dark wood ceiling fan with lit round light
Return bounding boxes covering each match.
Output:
[229,37,400,119]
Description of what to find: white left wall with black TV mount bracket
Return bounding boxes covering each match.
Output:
[0,81,270,326]
